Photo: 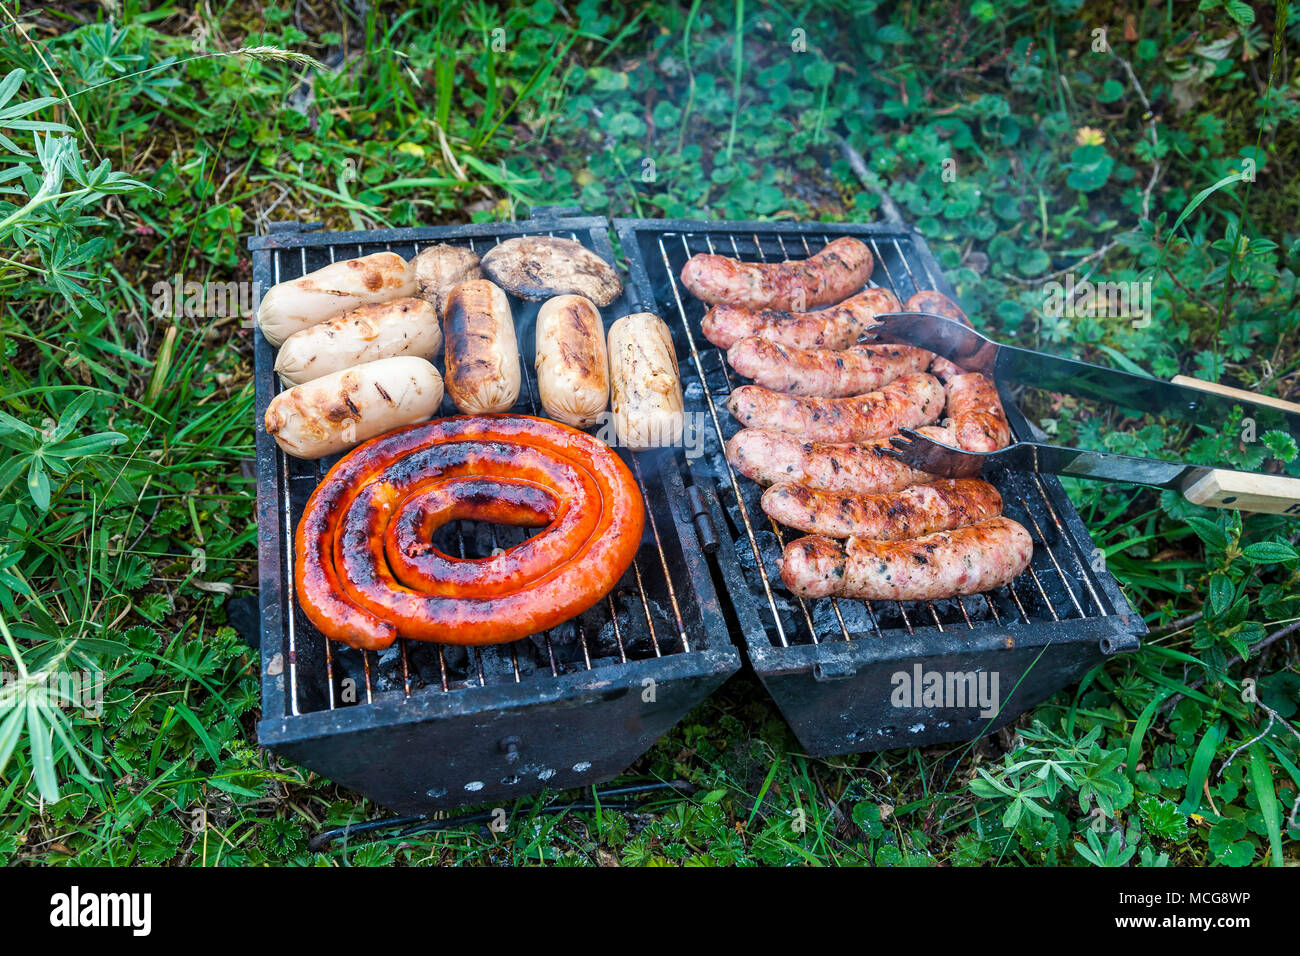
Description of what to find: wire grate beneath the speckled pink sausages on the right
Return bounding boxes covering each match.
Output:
[616,221,1122,648]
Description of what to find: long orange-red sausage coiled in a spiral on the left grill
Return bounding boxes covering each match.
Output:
[294,415,645,650]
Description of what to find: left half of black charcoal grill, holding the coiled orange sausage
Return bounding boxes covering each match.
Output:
[248,208,740,813]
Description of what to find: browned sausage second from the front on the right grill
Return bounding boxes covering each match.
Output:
[763,479,1002,541]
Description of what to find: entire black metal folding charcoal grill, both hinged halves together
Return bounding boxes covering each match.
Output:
[250,207,1145,813]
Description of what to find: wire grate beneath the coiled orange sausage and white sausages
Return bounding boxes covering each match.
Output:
[255,217,707,715]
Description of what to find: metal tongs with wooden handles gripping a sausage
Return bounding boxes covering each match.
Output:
[866,312,1300,515]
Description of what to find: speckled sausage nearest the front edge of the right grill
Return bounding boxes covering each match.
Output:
[781,518,1034,601]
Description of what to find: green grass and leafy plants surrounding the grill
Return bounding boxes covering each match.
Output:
[0,0,1300,866]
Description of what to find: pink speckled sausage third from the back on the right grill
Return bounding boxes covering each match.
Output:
[727,336,935,398]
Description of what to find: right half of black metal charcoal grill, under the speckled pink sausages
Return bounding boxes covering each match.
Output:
[614,220,1145,754]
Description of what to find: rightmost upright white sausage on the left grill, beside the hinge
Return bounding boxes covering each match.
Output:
[610,312,685,449]
